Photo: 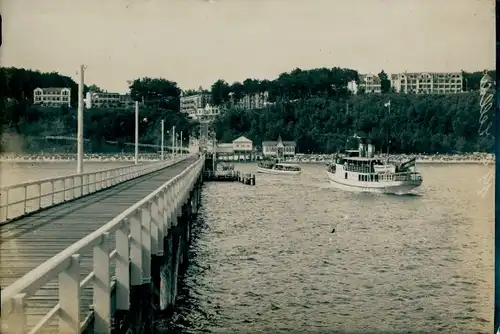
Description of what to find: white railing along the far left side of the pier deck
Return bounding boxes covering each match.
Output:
[0,156,186,224]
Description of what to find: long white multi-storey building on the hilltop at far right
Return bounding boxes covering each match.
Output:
[390,72,463,94]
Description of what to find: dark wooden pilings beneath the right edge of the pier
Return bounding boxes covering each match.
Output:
[113,175,203,333]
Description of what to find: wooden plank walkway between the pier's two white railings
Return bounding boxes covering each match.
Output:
[0,157,197,333]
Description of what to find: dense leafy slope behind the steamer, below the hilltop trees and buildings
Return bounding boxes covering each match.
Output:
[214,93,494,153]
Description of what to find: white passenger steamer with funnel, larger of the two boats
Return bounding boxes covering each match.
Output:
[326,139,423,194]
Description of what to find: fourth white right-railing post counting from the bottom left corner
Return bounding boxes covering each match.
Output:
[115,218,130,311]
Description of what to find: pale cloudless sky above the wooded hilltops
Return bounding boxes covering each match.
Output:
[0,0,495,93]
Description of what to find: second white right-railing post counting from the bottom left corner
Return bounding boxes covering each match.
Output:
[59,254,80,334]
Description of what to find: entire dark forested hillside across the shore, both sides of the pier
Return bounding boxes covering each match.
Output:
[0,67,495,153]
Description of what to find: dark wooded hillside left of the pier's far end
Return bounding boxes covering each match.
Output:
[0,68,197,152]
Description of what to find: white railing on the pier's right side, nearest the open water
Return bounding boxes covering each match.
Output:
[1,156,205,334]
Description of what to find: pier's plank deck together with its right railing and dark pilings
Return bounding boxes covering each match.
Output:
[0,156,204,334]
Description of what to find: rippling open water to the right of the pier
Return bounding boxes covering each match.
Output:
[158,165,493,333]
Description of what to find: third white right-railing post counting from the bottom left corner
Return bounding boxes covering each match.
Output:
[93,232,111,334]
